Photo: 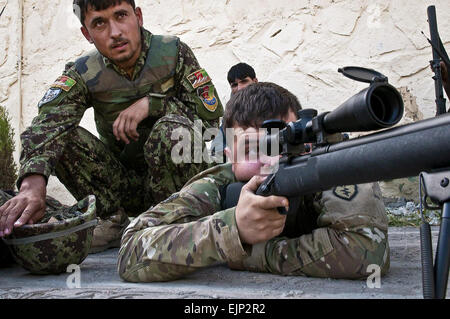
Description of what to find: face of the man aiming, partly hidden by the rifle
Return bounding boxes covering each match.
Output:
[225,111,297,182]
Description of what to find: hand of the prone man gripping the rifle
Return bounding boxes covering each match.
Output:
[236,176,289,245]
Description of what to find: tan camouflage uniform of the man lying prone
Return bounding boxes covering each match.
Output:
[118,163,389,282]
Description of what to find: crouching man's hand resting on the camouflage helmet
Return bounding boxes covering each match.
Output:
[0,175,47,237]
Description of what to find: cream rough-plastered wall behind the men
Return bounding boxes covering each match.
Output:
[0,0,450,202]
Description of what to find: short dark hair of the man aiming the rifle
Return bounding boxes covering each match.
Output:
[223,82,302,129]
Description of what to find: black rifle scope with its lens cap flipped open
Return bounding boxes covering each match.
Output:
[263,67,404,149]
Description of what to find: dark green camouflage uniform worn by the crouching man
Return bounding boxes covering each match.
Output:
[17,29,223,217]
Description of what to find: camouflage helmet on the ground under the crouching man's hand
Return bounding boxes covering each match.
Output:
[4,195,97,275]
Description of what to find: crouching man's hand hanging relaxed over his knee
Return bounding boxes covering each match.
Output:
[113,96,149,144]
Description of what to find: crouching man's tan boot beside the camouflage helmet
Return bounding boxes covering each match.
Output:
[89,209,130,254]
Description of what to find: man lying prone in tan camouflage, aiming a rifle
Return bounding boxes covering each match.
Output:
[118,82,389,282]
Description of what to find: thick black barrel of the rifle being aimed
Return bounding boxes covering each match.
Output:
[271,113,450,196]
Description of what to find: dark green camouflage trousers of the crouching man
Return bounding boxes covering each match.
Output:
[55,115,209,218]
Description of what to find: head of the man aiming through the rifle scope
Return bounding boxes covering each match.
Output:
[223,82,301,182]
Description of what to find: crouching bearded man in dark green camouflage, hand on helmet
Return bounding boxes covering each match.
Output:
[0,0,223,255]
